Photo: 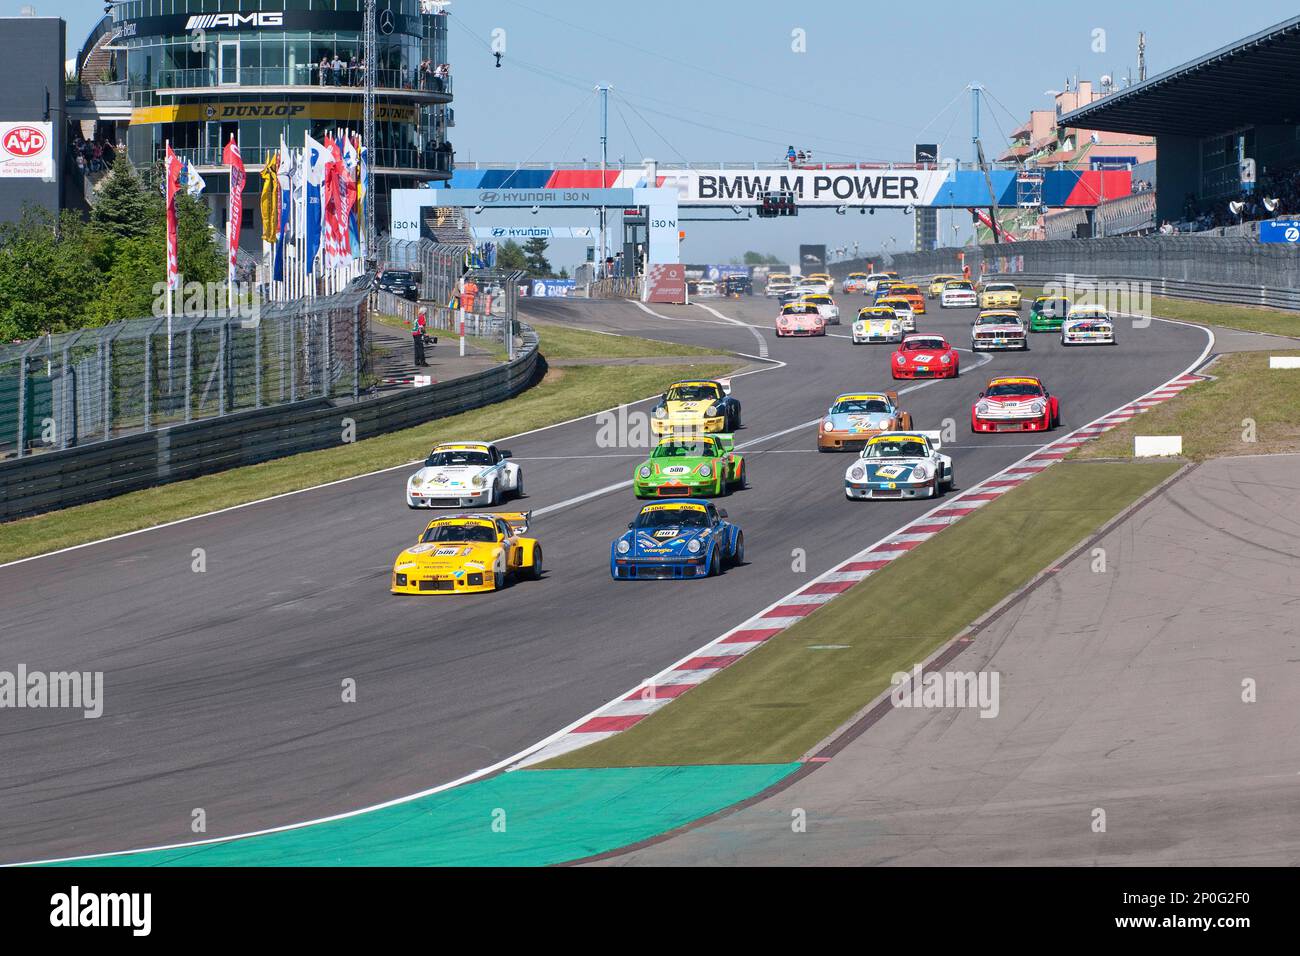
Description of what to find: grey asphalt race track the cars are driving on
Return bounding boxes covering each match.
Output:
[0,295,1206,862]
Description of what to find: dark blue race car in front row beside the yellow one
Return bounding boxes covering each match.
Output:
[610,498,745,581]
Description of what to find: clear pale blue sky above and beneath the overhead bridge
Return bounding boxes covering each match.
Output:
[27,0,1296,267]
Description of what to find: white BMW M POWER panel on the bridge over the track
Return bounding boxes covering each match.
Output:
[663,169,948,207]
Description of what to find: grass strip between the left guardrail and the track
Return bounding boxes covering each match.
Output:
[0,332,737,563]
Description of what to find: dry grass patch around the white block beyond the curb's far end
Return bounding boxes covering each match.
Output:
[1071,351,1300,460]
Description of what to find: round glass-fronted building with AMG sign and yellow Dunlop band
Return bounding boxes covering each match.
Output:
[113,0,452,235]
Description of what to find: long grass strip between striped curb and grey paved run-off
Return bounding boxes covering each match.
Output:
[541,462,1180,767]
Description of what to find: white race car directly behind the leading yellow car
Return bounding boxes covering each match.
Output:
[407,441,524,507]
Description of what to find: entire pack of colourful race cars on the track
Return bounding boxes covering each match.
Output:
[391,273,1114,594]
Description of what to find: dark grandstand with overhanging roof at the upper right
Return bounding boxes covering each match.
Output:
[1058,17,1300,232]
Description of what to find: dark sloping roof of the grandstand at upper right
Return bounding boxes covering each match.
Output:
[1058,17,1300,137]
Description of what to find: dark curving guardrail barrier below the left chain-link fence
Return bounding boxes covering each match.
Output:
[0,324,541,520]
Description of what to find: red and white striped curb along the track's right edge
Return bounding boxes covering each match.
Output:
[511,371,1206,769]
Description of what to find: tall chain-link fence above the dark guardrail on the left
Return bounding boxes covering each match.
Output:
[0,277,369,458]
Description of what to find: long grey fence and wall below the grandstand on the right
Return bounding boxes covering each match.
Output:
[831,235,1300,311]
